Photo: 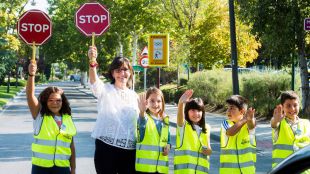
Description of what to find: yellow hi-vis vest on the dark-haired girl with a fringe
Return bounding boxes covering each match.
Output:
[174,121,210,174]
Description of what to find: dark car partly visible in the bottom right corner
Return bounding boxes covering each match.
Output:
[269,145,310,174]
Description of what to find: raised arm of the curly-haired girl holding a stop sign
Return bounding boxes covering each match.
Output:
[26,61,40,119]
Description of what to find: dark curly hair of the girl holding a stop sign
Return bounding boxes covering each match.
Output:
[39,86,71,116]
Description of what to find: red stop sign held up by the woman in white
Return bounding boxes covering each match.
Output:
[75,3,110,36]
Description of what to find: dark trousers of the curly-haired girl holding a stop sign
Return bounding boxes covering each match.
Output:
[31,164,70,174]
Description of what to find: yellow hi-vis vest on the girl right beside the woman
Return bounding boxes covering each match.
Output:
[136,114,169,173]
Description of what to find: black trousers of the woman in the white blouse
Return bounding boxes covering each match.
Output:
[94,139,136,174]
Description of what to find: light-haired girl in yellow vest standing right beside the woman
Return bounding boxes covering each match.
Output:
[136,87,171,173]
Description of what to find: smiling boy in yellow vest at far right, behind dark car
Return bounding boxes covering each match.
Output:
[271,91,310,167]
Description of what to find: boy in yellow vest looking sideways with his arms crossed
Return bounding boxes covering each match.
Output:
[219,95,256,174]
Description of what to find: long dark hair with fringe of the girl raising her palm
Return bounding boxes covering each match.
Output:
[184,98,207,133]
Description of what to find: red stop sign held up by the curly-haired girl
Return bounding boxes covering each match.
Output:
[17,10,52,45]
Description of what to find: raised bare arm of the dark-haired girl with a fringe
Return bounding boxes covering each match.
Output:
[177,89,193,127]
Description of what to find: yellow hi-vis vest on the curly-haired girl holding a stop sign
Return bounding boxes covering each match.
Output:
[32,115,76,167]
